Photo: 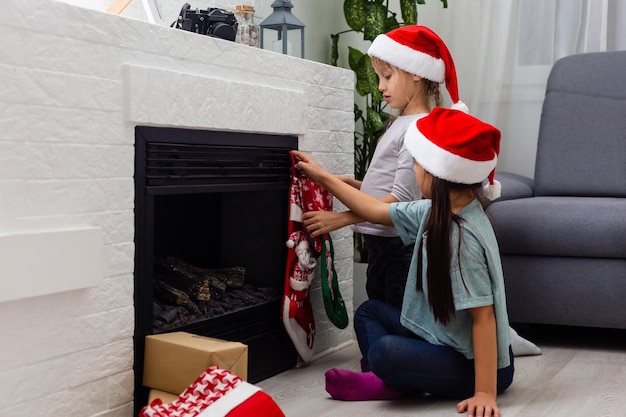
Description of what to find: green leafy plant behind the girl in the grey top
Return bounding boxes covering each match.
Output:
[330,0,448,262]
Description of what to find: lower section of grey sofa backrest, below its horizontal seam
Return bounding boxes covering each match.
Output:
[534,92,626,197]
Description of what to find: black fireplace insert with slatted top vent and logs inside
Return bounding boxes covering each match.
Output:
[135,126,298,404]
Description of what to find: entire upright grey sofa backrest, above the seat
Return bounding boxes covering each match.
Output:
[534,51,626,197]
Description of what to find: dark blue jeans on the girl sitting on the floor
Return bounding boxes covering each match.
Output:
[354,300,514,400]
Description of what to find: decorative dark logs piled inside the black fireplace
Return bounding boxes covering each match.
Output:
[153,256,280,332]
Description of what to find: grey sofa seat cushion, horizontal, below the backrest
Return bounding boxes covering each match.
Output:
[487,197,626,259]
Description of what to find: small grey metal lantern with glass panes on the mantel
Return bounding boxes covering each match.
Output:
[259,0,304,58]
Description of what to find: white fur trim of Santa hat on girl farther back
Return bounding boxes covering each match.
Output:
[367,34,446,83]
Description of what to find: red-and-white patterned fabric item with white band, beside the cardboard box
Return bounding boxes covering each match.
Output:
[139,366,285,417]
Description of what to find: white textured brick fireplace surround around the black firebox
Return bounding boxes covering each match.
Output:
[0,0,354,417]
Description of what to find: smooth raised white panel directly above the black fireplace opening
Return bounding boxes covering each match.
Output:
[124,64,308,136]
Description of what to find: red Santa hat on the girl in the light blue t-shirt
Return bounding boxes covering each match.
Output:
[404,107,501,200]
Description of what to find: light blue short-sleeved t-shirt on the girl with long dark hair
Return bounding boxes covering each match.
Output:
[389,200,511,368]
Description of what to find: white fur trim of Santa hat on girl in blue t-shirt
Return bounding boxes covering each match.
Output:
[404,123,498,184]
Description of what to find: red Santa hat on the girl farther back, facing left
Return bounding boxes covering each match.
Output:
[367,25,468,113]
